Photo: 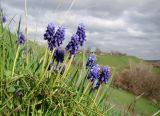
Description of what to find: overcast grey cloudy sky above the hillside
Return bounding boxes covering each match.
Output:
[1,0,160,60]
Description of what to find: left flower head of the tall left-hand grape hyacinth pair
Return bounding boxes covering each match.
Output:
[44,23,55,42]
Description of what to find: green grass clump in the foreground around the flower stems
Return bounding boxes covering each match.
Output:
[0,12,115,116]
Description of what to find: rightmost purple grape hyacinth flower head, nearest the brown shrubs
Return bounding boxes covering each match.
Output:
[99,67,111,84]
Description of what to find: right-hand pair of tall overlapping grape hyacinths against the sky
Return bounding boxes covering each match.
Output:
[66,24,86,56]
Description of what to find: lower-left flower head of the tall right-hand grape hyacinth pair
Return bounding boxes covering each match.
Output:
[66,34,79,56]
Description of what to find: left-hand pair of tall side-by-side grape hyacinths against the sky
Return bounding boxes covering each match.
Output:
[44,23,65,50]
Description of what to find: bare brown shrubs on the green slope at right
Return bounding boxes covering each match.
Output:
[113,62,160,101]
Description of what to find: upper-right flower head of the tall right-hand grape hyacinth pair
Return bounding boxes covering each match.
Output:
[76,23,86,46]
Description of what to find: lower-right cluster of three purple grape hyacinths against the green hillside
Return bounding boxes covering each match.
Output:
[86,54,111,89]
